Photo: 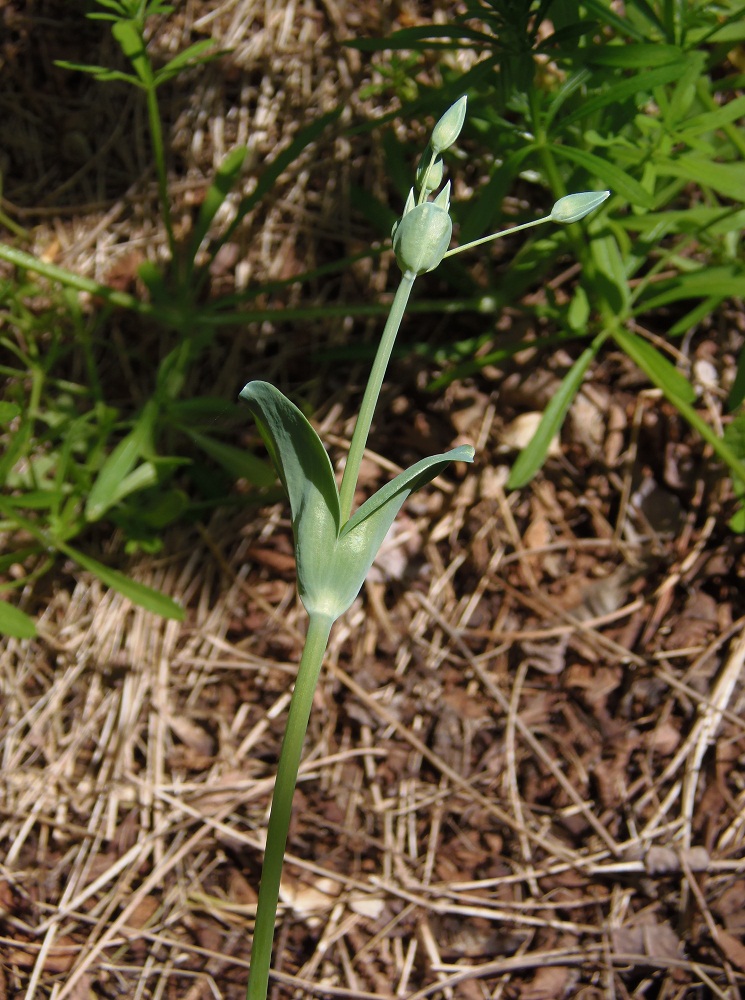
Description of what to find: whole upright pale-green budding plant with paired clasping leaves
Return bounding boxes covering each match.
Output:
[240,97,609,1000]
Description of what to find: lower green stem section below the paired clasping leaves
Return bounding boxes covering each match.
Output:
[246,614,333,1000]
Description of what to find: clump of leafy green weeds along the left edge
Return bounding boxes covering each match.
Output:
[0,0,336,637]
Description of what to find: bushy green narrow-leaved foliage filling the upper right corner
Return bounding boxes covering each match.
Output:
[351,0,745,520]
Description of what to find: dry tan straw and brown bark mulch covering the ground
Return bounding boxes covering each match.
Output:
[0,0,745,1000]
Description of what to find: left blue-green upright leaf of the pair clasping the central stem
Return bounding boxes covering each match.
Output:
[240,381,341,614]
